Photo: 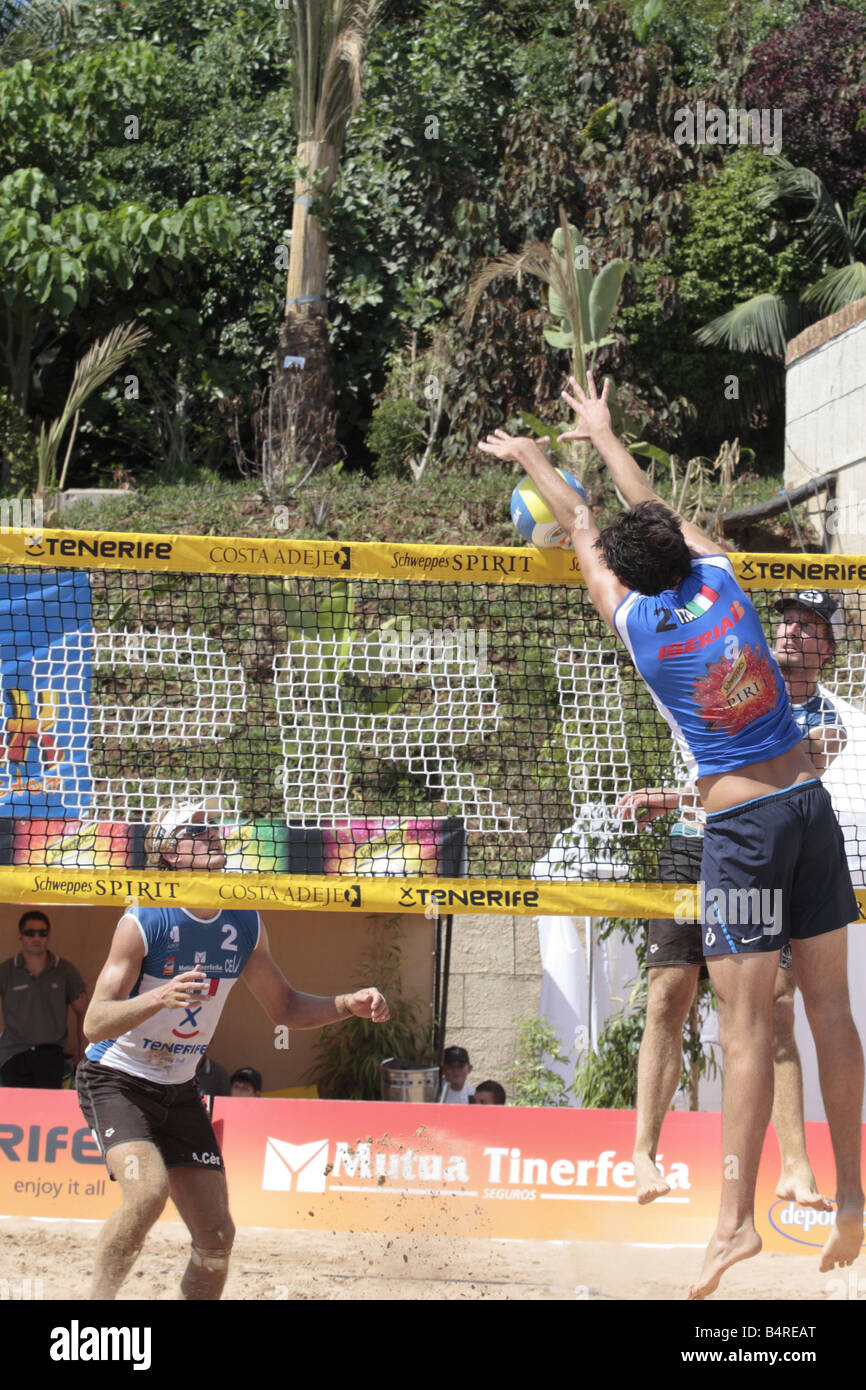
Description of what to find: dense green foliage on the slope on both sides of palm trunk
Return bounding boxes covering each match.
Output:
[0,0,845,489]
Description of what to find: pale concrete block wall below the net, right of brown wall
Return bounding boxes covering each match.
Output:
[445,915,541,1091]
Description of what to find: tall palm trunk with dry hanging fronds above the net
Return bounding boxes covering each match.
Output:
[278,0,379,475]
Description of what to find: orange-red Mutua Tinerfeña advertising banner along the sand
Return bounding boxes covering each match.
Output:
[0,1090,856,1254]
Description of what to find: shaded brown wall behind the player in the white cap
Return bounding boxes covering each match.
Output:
[0,904,435,1090]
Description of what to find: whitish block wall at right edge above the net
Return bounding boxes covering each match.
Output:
[785,299,866,555]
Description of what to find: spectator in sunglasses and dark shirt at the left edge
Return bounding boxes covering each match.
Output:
[0,908,88,1091]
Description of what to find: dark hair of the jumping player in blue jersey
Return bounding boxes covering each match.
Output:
[595,502,692,594]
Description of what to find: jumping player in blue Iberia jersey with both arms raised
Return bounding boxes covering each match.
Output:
[480,375,863,1298]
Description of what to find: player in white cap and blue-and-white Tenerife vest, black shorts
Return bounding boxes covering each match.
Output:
[76,802,389,1300]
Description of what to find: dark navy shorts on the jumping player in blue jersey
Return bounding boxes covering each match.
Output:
[701,778,859,956]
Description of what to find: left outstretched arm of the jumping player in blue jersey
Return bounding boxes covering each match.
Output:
[478,430,628,627]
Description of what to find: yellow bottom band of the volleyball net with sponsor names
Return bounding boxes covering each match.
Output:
[6,866,866,922]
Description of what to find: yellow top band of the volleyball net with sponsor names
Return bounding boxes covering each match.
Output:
[0,531,866,589]
